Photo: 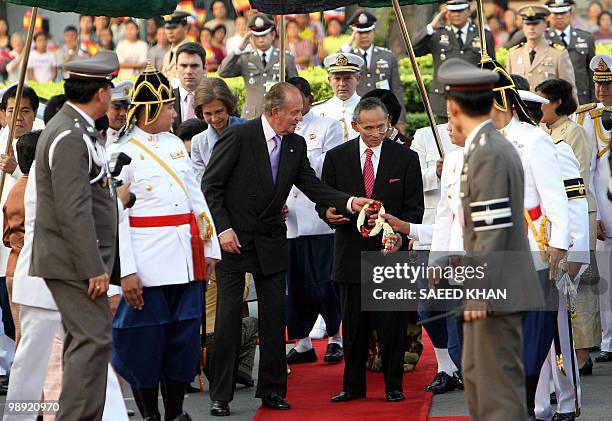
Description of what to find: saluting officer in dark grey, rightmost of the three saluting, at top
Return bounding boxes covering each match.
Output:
[414,0,495,123]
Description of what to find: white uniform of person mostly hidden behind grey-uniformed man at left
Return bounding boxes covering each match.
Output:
[4,164,128,421]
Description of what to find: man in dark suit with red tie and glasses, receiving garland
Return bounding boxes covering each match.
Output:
[317,98,425,402]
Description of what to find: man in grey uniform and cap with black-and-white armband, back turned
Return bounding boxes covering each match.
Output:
[438,58,541,421]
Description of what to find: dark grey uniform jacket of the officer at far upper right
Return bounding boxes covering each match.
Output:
[544,28,595,104]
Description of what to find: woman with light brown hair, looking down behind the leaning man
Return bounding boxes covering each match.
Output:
[191,77,245,182]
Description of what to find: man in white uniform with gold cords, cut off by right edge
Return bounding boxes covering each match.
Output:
[576,54,612,362]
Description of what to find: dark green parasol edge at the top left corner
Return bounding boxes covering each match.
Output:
[8,0,177,18]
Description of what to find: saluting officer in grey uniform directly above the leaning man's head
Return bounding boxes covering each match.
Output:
[217,13,298,120]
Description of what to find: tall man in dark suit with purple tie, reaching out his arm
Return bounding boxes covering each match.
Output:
[202,83,369,416]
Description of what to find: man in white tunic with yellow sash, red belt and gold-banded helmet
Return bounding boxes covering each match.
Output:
[111,65,221,421]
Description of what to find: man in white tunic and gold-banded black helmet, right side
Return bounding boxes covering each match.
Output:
[491,68,570,415]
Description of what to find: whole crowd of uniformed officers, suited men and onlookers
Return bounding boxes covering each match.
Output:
[0,0,612,421]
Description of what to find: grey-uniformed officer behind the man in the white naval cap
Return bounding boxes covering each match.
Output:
[342,11,406,133]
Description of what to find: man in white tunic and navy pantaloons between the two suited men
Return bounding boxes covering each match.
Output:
[286,77,344,364]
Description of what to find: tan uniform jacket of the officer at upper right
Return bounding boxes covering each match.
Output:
[506,37,577,98]
